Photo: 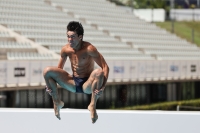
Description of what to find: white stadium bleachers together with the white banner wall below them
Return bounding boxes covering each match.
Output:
[0,0,200,98]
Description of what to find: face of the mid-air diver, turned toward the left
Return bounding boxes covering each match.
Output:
[67,31,82,48]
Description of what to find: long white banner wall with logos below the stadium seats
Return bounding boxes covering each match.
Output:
[0,60,200,87]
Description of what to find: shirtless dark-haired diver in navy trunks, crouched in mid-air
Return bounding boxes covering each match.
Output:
[43,21,109,123]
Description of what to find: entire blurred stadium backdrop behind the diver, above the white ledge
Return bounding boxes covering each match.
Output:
[0,0,200,111]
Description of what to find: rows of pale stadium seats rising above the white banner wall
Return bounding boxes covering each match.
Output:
[0,0,200,60]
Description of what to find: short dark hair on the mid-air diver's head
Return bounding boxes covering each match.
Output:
[67,21,84,36]
